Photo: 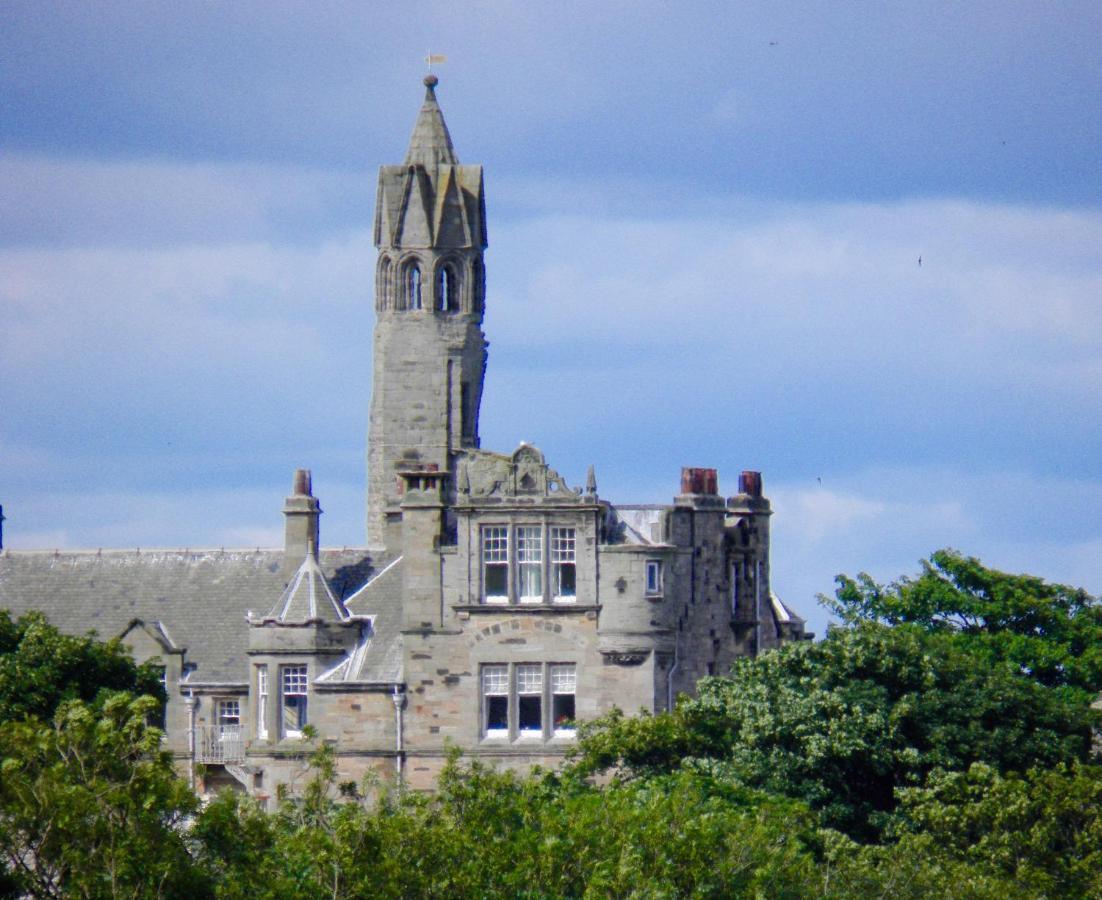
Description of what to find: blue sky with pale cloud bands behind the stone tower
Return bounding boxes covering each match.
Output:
[0,0,1102,633]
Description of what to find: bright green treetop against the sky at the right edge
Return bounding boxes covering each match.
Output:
[820,550,1102,695]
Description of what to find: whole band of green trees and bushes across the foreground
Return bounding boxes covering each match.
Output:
[0,551,1102,900]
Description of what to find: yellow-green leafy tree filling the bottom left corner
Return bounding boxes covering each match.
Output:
[0,693,206,897]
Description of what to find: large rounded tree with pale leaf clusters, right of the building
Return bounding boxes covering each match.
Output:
[574,622,1094,841]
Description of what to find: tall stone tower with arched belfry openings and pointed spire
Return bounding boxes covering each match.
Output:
[367,75,487,550]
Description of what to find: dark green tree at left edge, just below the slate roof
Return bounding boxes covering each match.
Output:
[0,610,164,722]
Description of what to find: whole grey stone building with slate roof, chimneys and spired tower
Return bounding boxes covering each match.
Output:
[0,76,810,796]
